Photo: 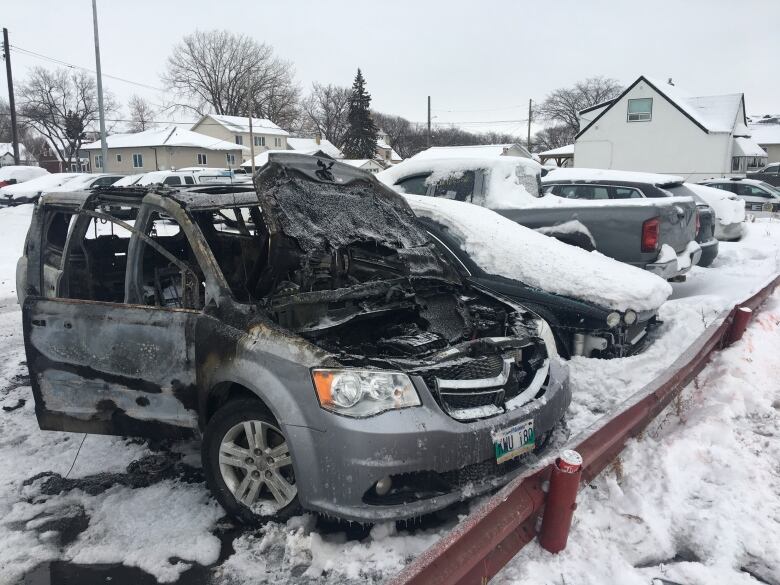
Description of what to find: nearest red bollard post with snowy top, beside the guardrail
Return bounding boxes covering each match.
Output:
[539,449,582,554]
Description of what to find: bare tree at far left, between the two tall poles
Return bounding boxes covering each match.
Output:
[19,67,117,168]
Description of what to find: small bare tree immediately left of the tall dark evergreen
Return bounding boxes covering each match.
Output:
[301,82,350,148]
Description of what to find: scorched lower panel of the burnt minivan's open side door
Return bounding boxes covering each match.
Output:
[23,204,201,437]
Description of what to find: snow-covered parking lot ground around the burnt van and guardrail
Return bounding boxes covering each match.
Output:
[0,205,780,585]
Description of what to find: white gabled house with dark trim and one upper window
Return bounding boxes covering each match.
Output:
[574,76,766,180]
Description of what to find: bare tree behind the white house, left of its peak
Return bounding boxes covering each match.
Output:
[536,77,622,134]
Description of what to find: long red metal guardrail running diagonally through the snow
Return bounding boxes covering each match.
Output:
[389,276,780,585]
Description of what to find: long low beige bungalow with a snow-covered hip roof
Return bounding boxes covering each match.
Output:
[81,126,249,174]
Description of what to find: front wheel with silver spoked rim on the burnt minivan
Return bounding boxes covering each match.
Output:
[201,399,300,524]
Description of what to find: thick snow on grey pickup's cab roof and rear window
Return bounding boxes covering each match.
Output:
[376,156,542,209]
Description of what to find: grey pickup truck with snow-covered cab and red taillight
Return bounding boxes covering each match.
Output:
[378,156,701,280]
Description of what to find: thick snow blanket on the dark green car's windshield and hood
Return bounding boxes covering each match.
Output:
[405,195,672,311]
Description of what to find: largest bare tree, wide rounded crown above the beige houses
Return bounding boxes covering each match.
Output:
[162,30,297,124]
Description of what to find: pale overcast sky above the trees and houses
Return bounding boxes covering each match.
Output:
[0,0,780,135]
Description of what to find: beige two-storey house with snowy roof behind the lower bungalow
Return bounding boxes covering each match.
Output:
[190,114,290,163]
